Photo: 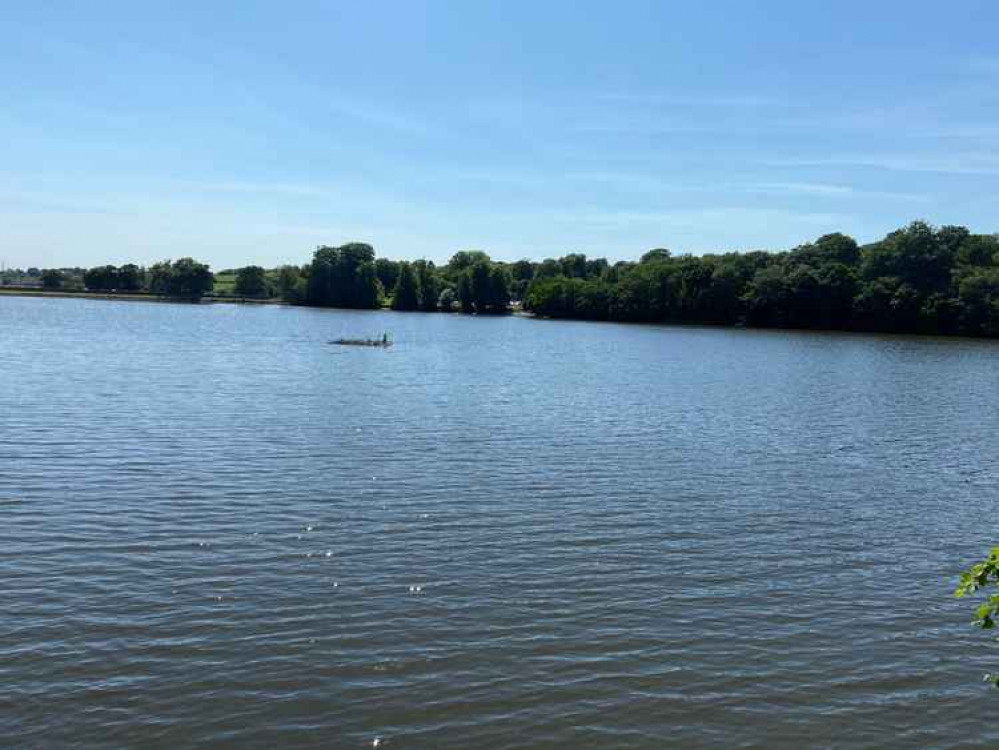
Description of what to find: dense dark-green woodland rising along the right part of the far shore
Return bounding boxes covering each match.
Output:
[524,221,999,336]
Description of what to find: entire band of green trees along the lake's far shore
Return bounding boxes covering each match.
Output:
[0,221,999,337]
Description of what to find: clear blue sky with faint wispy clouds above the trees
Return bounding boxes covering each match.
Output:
[0,0,999,269]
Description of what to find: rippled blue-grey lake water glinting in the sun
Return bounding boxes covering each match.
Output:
[0,298,999,750]
